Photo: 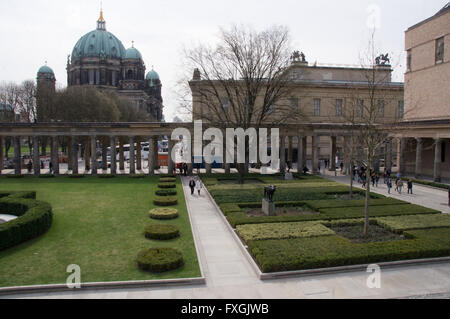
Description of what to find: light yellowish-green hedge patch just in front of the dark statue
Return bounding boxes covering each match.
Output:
[236,222,335,242]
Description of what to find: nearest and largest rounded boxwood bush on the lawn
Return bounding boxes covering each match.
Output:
[136,248,184,273]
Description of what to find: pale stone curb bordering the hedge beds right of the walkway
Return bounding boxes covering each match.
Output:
[205,180,450,280]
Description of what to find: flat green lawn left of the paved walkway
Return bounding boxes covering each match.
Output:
[0,177,200,287]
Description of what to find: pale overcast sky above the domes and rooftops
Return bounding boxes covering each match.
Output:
[0,0,447,121]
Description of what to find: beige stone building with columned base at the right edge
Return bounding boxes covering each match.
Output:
[392,3,450,182]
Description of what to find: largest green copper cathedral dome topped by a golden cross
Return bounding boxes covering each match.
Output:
[72,12,125,59]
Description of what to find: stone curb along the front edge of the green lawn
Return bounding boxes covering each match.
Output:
[0,277,206,296]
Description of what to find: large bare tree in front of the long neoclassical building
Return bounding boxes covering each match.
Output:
[183,26,300,182]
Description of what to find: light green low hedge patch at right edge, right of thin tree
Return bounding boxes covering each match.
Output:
[376,214,450,233]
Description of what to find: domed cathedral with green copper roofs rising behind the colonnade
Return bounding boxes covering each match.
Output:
[37,11,164,122]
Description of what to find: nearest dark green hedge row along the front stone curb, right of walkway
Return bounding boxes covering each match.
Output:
[248,228,450,272]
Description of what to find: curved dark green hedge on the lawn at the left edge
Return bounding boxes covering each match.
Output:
[0,192,53,251]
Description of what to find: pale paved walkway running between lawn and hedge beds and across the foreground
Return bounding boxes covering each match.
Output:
[4,179,450,299]
